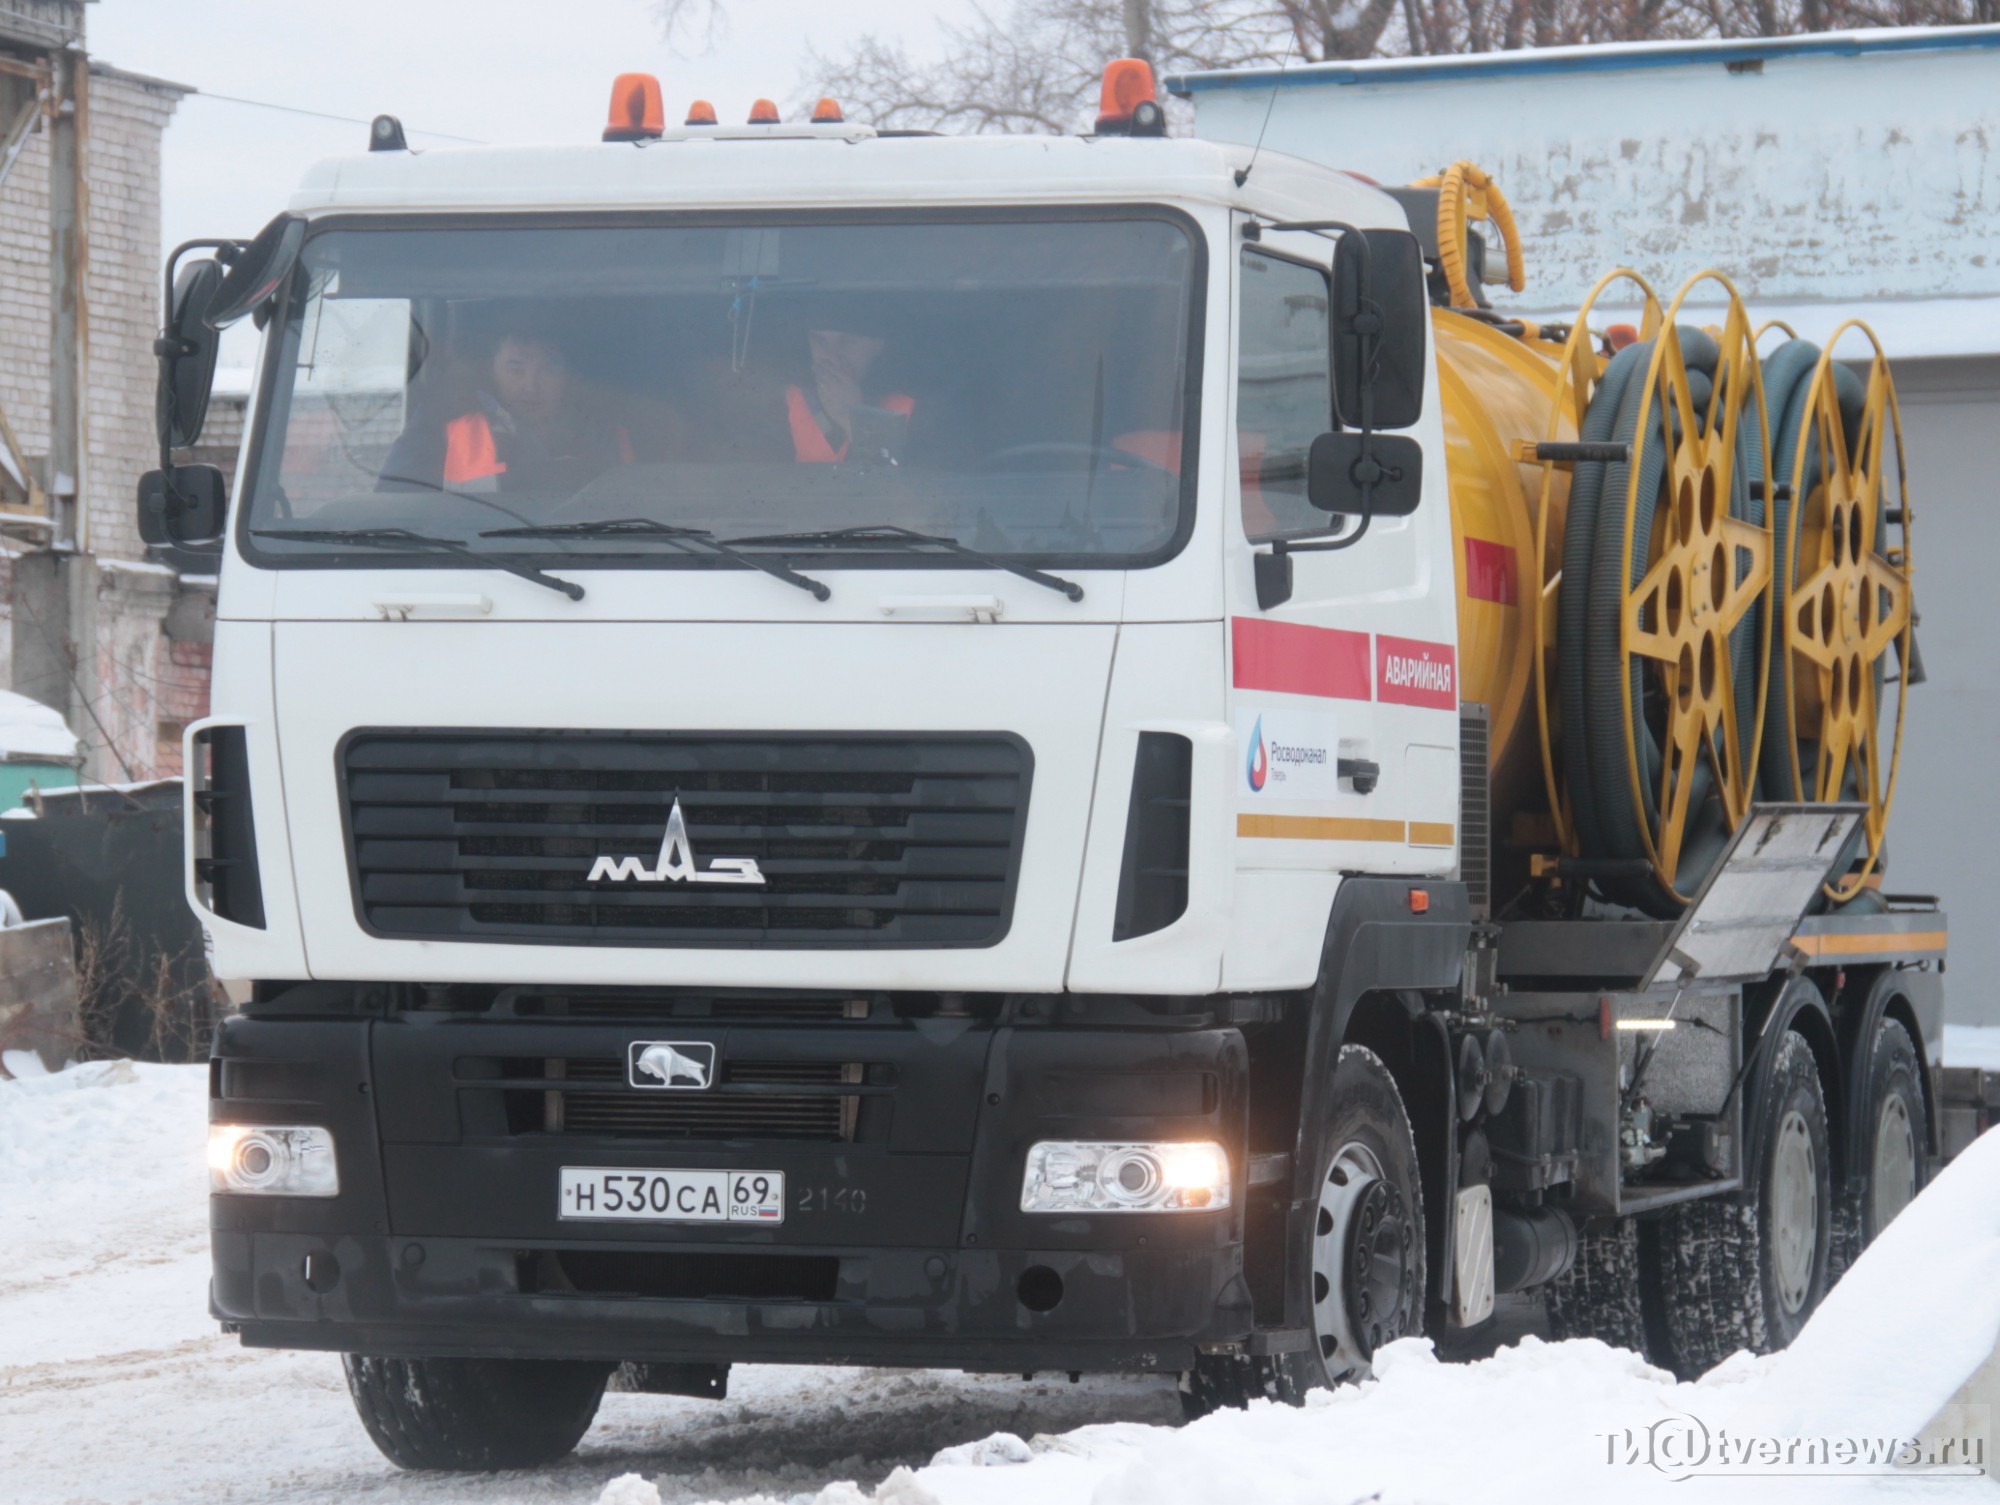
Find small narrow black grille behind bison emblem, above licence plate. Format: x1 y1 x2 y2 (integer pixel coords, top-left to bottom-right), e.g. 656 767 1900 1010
504 1059 866 1143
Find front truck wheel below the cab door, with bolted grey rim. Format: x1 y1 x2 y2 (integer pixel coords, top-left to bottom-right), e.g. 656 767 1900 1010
1180 1045 1424 1417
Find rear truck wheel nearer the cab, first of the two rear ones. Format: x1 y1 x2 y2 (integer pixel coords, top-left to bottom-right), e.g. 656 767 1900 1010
1646 1033 1834 1379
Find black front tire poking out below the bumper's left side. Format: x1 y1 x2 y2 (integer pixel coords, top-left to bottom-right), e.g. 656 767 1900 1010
342 1353 610 1471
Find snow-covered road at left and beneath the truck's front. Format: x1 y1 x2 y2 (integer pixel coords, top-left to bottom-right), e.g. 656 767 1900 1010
0 1063 1180 1505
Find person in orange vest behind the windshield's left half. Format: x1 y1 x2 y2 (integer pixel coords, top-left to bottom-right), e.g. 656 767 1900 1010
380 326 634 490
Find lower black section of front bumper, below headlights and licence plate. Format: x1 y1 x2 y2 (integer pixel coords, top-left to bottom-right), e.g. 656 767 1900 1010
212 1231 1250 1373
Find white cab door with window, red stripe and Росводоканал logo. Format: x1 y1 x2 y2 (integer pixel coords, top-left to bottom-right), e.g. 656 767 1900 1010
1230 232 1458 900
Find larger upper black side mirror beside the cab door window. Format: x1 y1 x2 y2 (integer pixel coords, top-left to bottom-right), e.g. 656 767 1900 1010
1330 230 1430 432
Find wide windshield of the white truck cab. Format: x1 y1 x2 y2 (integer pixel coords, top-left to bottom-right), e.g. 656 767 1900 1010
244 212 1198 568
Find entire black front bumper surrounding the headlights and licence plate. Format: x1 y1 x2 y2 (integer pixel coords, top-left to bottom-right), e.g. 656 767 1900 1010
210 999 1254 1371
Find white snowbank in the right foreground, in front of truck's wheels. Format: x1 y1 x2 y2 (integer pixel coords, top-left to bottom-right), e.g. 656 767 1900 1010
780 1135 2000 1505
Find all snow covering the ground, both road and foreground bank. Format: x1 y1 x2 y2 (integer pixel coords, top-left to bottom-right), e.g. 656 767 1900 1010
0 1037 2000 1505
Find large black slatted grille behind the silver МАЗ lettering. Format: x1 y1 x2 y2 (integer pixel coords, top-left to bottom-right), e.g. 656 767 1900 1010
340 730 1032 947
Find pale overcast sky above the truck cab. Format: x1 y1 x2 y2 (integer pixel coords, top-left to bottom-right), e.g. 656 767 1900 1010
88 0 964 254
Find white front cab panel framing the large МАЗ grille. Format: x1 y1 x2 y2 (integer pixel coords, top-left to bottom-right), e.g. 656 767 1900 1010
274 616 1120 991
